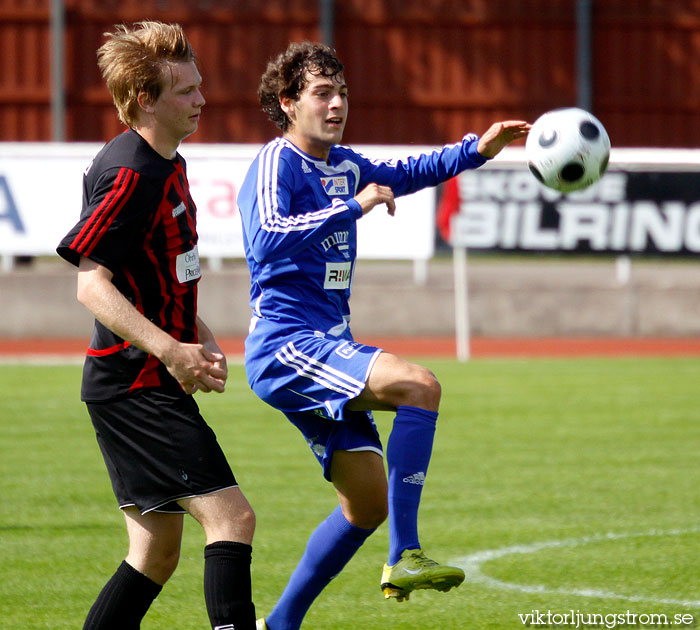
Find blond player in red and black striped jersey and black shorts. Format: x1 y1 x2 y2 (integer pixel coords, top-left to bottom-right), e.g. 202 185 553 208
58 22 255 630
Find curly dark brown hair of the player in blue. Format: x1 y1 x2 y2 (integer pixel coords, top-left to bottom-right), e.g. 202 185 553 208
258 42 343 131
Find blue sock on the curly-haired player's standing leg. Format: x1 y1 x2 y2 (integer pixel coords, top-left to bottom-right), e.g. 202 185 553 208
265 506 374 630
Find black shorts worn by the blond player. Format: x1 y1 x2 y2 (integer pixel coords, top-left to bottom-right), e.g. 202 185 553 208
87 389 237 514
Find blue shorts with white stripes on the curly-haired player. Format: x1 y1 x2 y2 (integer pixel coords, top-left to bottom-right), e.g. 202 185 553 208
246 320 382 481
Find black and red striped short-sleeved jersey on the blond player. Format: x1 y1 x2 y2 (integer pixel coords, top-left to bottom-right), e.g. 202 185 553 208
57 130 200 401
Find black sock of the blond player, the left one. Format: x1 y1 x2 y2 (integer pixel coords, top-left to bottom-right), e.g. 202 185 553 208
83 561 163 630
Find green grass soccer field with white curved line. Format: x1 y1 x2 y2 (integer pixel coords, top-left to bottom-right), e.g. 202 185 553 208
0 358 700 630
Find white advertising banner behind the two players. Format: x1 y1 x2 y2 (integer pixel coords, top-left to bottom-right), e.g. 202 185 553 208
0 143 435 272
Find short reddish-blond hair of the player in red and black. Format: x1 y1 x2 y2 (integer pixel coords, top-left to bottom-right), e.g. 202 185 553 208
97 21 196 127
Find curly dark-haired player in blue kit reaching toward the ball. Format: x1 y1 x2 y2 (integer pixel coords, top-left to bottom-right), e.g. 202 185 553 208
238 42 530 630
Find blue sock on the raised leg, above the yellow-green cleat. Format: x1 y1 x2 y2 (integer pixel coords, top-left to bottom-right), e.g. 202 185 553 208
386 406 438 565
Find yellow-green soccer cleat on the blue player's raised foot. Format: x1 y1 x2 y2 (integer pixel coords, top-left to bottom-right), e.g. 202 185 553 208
381 549 464 602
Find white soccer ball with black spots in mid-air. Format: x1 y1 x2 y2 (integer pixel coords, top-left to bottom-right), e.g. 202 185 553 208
525 107 610 193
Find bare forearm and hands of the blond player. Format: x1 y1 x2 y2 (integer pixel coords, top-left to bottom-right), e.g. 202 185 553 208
78 257 226 394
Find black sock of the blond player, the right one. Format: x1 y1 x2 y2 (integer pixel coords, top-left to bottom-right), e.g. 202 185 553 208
204 541 255 630
